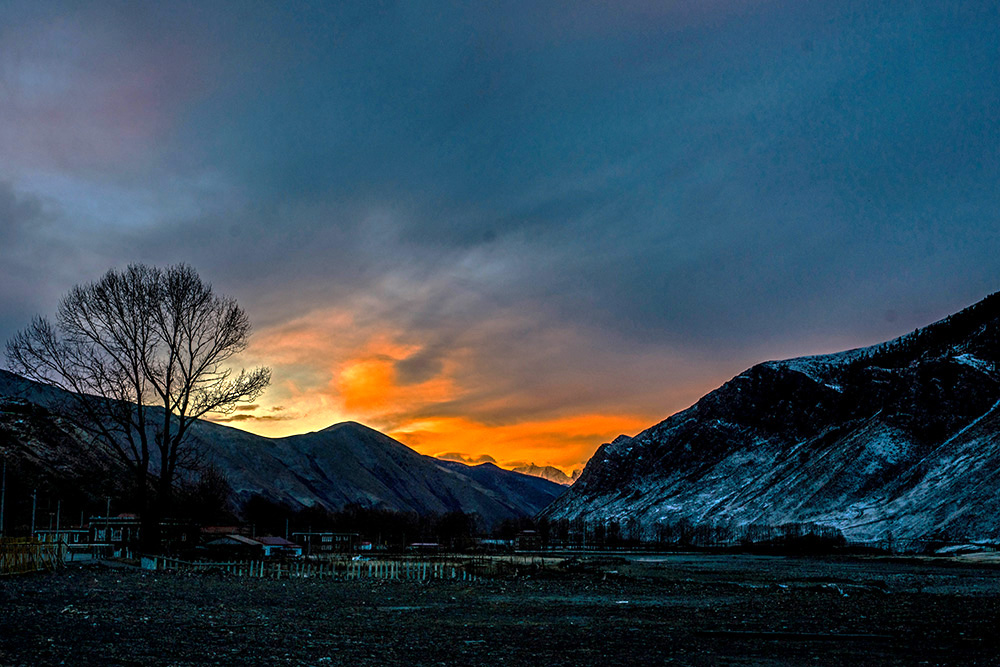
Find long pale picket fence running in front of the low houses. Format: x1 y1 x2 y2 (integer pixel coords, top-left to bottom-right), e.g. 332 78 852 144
142 556 481 581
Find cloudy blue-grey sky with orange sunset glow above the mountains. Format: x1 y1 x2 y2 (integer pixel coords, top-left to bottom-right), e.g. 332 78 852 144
0 0 1000 478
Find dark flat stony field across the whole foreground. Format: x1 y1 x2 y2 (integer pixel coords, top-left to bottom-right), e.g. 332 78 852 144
0 556 1000 666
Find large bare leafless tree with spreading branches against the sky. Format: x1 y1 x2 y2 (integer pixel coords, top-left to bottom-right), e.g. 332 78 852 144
7 264 271 546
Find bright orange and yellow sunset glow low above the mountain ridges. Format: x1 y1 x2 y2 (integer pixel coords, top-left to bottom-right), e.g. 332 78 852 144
211 310 728 473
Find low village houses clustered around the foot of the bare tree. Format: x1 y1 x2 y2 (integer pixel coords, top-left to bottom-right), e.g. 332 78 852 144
34 514 372 560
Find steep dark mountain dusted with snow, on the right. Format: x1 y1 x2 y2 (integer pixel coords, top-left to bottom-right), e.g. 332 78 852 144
542 293 1000 544
